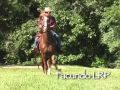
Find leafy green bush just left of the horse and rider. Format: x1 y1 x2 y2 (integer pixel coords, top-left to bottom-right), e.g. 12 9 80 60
5 20 38 63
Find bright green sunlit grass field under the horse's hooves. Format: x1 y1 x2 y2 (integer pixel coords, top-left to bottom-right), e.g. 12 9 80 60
0 66 120 90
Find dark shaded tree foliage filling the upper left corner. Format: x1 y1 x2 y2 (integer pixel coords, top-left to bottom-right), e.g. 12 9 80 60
0 0 39 32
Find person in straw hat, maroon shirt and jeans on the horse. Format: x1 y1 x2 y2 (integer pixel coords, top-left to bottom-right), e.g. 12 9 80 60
34 7 61 52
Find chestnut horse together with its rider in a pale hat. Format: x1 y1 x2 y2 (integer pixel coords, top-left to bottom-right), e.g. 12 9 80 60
35 7 60 75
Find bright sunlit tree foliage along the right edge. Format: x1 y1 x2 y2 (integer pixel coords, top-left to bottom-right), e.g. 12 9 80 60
100 0 120 67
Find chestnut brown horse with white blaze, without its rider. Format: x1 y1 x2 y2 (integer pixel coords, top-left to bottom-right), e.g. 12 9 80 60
39 17 58 75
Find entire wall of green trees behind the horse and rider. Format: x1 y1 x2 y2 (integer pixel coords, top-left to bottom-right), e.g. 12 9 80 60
0 0 120 67
